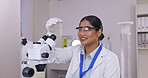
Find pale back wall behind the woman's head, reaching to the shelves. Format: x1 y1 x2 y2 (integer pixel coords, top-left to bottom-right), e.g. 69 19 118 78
50 0 137 78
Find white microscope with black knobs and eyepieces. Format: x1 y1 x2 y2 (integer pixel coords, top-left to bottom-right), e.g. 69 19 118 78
21 34 56 78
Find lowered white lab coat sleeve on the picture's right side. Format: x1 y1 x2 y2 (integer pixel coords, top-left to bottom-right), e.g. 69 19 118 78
104 53 120 78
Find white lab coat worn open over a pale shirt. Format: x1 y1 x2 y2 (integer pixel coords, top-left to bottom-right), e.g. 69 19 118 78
49 45 120 78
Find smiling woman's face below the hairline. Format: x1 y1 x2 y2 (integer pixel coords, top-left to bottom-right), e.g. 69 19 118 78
78 20 102 46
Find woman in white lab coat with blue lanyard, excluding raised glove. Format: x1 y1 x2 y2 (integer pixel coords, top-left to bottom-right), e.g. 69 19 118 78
49 15 120 78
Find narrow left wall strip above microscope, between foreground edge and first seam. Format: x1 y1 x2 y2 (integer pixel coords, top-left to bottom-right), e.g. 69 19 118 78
21 0 34 41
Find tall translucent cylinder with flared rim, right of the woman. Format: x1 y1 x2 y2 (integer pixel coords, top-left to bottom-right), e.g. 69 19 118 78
118 21 133 78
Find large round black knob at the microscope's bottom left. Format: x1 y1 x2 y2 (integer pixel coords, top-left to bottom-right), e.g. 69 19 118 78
22 67 34 77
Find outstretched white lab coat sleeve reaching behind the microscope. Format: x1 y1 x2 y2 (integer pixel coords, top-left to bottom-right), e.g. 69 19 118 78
48 46 78 63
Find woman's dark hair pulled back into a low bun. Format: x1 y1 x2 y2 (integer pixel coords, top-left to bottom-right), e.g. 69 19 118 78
79 15 104 41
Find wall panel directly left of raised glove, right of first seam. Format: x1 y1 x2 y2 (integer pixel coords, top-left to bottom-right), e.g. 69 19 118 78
33 0 49 41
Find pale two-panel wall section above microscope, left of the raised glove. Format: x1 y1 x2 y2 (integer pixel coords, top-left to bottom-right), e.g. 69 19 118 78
21 0 49 41
